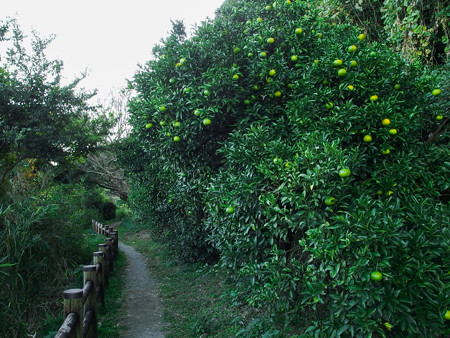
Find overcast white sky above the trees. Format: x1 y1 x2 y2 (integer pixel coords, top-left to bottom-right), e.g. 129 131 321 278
0 0 224 103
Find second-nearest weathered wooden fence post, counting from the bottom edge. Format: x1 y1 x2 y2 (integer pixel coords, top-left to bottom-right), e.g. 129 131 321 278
83 265 97 338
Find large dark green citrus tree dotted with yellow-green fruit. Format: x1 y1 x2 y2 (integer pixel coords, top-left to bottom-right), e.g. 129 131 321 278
124 1 450 337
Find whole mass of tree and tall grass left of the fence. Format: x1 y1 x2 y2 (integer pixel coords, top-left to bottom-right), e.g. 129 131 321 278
0 20 114 337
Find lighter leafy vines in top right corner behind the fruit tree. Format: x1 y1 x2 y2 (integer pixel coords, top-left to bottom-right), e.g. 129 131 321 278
319 0 450 64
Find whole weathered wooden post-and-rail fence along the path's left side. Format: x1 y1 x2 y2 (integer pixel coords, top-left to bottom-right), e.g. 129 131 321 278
55 220 119 338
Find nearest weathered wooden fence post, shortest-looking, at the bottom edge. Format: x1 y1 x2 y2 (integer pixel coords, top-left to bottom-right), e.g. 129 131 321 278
55 289 83 338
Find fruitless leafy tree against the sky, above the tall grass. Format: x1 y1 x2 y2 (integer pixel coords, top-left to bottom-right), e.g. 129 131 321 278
0 21 109 183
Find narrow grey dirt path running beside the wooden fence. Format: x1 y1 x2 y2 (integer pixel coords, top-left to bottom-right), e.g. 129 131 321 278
119 241 165 338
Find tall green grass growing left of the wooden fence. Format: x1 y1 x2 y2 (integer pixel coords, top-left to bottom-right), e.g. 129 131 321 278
0 173 107 337
